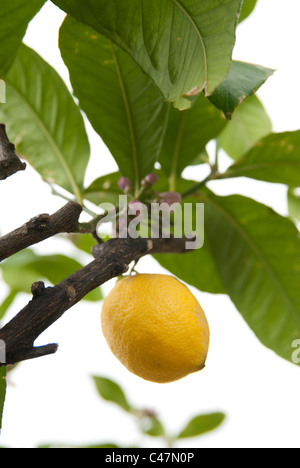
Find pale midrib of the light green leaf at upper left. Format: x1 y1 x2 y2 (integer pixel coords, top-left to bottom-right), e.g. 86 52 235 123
6 77 82 204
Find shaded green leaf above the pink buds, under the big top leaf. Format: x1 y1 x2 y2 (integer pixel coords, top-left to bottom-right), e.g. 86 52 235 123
159 95 226 183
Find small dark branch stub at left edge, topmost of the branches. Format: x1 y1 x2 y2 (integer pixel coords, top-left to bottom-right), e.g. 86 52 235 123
0 124 26 180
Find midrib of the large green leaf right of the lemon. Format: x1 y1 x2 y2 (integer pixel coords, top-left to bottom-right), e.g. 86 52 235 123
202 194 300 325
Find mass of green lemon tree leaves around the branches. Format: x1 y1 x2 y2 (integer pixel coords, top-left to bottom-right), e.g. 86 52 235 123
0 0 300 437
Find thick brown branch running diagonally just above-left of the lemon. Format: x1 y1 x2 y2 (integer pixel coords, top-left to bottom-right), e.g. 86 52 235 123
0 239 193 364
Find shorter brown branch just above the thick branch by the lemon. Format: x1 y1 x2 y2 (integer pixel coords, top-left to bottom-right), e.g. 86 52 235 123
0 202 82 262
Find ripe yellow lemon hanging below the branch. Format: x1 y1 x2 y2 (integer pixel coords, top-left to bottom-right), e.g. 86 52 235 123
101 274 209 383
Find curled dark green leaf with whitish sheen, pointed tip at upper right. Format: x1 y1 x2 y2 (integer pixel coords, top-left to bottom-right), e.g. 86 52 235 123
209 61 274 120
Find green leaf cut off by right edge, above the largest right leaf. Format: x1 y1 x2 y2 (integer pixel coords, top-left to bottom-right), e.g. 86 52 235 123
228 131 300 187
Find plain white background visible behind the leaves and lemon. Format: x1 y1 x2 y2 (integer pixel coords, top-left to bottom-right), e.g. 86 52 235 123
0 0 300 448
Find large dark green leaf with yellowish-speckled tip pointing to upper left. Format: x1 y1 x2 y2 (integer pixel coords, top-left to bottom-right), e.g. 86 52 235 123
60 17 168 190
